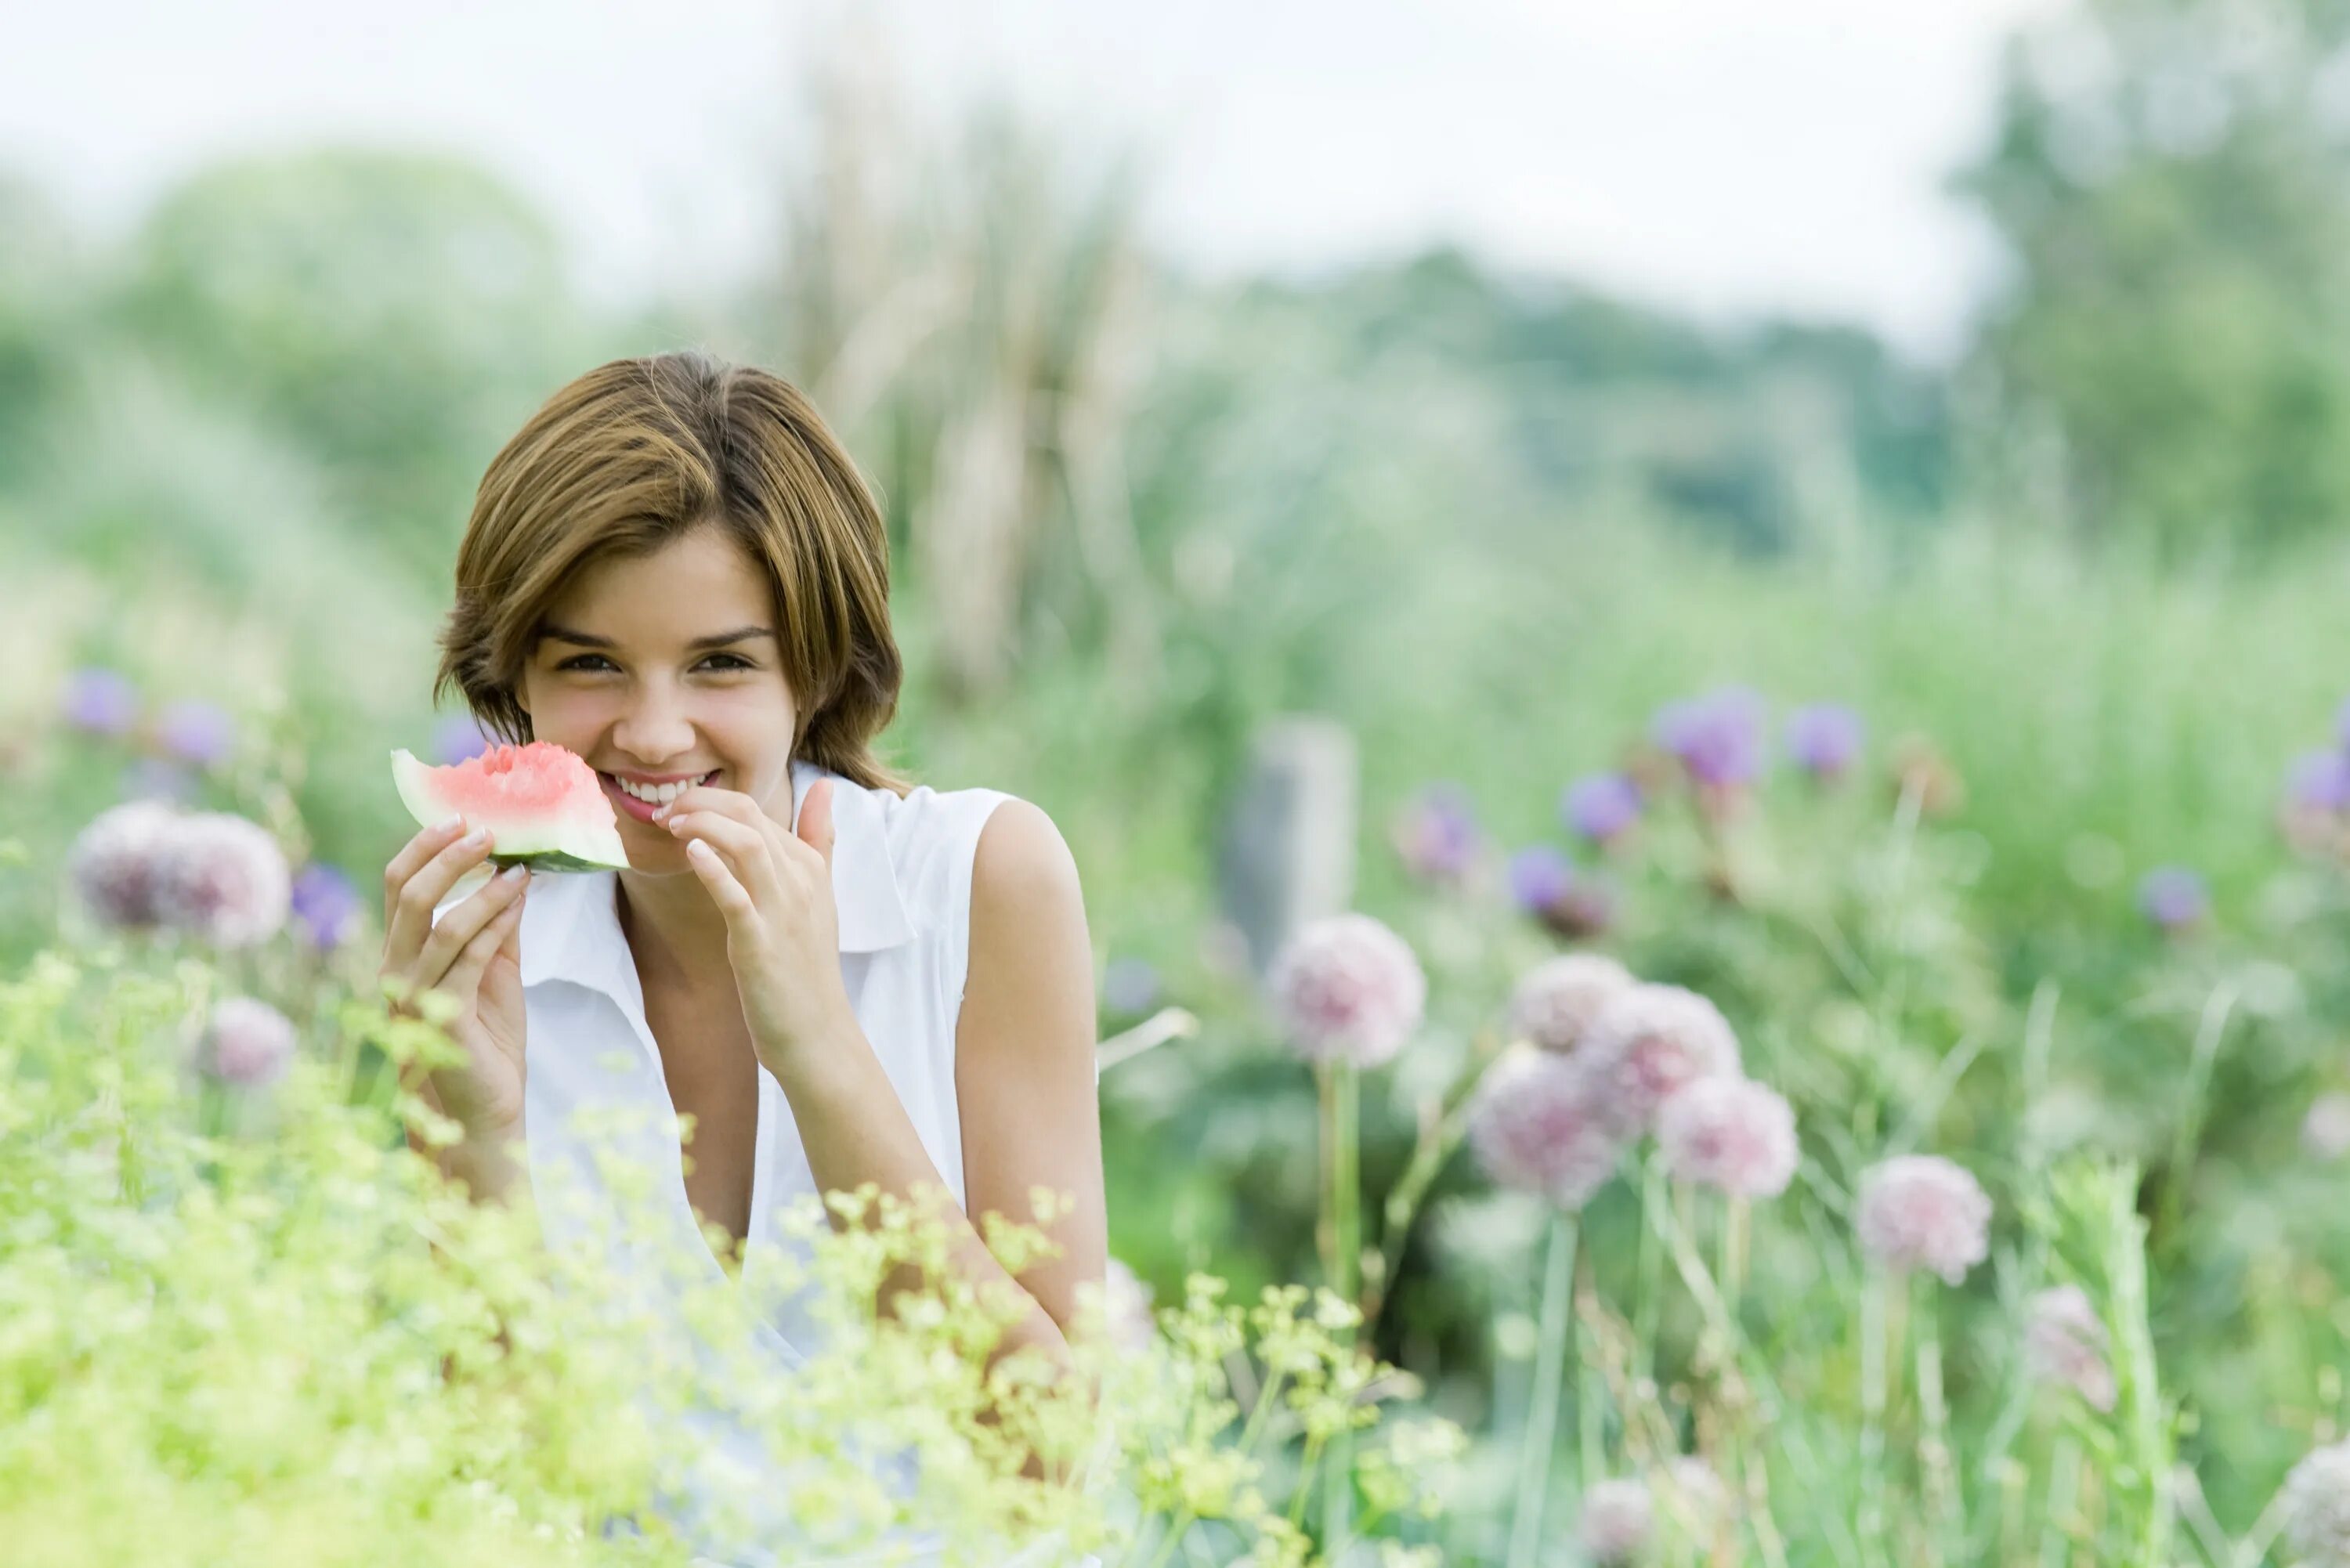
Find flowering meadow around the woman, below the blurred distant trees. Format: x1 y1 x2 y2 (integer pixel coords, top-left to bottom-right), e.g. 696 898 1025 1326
13 510 2350 1568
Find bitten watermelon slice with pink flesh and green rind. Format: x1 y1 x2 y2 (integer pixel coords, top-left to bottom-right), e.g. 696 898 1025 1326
392 740 627 877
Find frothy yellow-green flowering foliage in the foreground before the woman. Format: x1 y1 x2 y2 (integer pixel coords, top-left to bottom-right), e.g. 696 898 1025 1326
0 948 1459 1568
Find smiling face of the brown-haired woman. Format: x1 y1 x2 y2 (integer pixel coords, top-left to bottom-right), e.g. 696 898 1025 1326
517 529 797 861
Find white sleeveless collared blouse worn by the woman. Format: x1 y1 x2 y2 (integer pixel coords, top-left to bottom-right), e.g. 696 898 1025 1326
435 761 1058 1568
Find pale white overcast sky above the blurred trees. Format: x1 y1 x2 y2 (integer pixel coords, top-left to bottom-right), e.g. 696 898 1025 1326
0 0 2052 355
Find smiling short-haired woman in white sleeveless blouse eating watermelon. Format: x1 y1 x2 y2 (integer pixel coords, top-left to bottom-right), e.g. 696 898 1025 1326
383 350 1107 1560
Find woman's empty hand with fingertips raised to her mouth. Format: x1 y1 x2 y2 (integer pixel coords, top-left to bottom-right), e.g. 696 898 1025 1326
663 778 853 1070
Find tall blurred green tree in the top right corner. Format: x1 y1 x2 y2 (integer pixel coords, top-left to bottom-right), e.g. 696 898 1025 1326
1958 0 2350 555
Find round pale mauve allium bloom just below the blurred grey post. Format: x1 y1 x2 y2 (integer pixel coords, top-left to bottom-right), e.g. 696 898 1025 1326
1267 912 1429 1068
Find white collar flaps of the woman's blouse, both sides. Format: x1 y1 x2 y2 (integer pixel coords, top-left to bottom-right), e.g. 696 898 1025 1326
522 757 914 990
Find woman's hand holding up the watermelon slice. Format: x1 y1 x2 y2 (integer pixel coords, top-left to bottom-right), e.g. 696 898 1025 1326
381 823 529 1138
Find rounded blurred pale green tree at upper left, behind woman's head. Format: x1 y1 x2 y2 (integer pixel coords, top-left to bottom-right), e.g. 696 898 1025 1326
113 148 585 580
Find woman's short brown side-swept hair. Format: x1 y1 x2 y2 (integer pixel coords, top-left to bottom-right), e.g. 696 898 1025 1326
432 348 909 795
